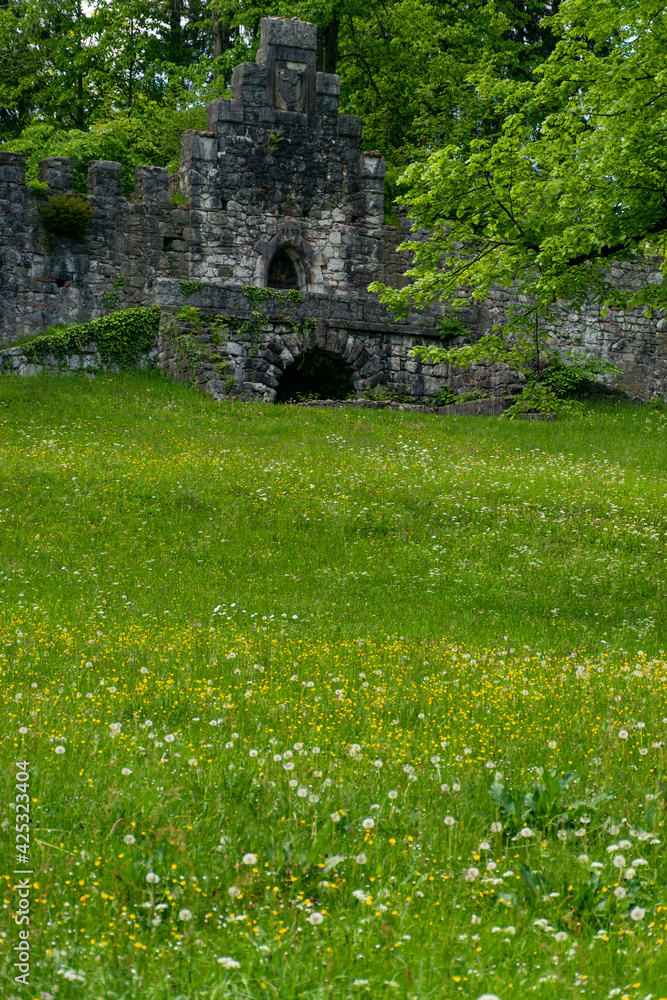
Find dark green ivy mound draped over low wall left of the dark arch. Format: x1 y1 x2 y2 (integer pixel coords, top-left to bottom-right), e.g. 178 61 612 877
21 306 160 367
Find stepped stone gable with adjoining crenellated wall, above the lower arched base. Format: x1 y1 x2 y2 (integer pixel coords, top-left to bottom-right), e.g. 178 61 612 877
0 18 418 344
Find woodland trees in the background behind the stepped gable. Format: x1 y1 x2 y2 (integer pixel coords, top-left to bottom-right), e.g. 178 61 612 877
0 0 564 187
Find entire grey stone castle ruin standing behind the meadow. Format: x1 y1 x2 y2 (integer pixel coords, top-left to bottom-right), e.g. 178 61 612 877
0 18 667 403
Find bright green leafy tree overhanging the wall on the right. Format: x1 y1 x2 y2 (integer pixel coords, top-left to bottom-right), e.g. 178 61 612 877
376 0 667 324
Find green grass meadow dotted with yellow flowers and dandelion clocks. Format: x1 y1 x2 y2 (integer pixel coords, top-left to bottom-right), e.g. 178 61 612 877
0 374 667 1000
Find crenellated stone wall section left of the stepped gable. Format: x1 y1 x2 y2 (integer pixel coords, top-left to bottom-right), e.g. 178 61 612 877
0 151 189 344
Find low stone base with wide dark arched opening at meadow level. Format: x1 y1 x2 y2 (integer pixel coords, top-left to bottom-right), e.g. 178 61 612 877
158 289 520 405
